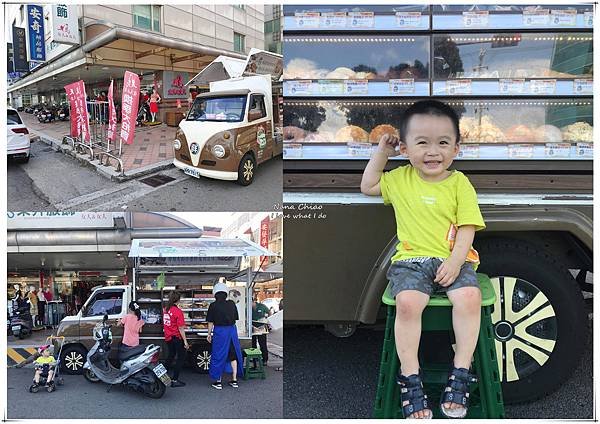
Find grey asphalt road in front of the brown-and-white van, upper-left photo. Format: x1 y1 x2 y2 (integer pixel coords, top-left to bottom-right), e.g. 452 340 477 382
7 141 282 212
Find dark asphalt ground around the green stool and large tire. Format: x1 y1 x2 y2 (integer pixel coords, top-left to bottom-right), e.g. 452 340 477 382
283 322 594 419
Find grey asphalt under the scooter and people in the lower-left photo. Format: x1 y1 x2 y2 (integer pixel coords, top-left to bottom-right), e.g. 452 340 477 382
7 367 283 419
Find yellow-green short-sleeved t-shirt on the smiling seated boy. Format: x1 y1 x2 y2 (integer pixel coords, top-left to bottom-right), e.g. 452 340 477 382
379 165 485 264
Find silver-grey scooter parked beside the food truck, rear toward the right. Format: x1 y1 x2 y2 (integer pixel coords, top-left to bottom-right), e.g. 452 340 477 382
83 314 171 399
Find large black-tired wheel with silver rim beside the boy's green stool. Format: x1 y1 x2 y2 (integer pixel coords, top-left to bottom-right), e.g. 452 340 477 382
475 239 588 404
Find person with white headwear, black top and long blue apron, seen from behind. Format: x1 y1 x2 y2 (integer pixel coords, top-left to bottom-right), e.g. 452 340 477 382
206 283 244 390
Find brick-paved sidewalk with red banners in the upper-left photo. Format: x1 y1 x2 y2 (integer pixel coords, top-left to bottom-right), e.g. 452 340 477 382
20 112 177 181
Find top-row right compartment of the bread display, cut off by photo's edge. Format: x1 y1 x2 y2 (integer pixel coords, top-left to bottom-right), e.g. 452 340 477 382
432 4 594 30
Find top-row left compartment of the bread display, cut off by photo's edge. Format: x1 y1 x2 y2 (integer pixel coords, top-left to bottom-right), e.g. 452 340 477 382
283 5 430 32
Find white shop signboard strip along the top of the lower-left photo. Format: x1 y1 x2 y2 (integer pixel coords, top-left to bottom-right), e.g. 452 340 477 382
7 212 125 231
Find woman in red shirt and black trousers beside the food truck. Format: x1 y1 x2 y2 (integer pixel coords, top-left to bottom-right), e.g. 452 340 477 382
163 291 190 387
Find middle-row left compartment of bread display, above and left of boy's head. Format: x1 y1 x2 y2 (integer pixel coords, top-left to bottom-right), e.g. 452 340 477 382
283 35 430 97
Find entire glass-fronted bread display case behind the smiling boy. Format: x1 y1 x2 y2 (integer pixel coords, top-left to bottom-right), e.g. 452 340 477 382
283 5 593 164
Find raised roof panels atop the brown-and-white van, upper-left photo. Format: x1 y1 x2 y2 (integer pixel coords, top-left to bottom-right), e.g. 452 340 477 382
186 48 283 85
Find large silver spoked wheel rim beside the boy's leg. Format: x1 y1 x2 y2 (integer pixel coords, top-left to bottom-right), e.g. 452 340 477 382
491 276 557 383
